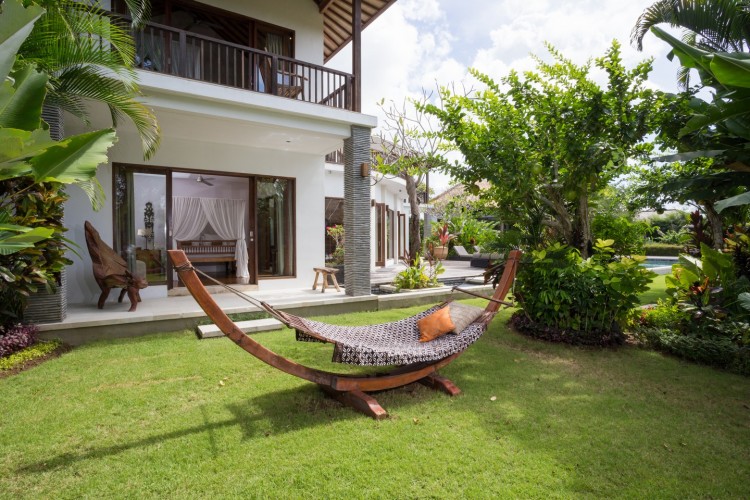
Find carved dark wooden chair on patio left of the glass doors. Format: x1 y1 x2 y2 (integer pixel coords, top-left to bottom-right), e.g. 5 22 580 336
84 221 148 312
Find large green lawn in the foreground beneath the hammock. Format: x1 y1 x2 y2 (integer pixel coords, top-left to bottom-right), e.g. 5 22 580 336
0 301 750 499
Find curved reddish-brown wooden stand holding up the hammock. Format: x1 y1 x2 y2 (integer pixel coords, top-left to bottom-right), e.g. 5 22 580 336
168 250 521 419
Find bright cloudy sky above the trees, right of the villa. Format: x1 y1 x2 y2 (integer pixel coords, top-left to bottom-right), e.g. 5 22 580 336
329 0 678 193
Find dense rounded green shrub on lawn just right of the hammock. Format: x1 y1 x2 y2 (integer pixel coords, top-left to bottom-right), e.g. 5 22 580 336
513 240 655 344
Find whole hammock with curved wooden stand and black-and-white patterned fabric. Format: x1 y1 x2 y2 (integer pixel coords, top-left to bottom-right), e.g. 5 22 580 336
168 250 521 418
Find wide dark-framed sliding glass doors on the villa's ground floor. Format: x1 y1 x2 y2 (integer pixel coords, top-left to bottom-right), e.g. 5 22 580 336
113 164 296 288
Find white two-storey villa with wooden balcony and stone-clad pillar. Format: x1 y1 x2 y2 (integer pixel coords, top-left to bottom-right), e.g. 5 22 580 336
58 0 396 316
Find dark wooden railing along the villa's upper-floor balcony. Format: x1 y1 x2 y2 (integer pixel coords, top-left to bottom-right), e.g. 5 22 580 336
125 18 353 110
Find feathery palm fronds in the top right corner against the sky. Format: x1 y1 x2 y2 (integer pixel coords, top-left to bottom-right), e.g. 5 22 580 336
630 0 750 88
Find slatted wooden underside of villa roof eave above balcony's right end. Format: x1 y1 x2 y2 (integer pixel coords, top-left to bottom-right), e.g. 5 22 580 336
313 0 396 62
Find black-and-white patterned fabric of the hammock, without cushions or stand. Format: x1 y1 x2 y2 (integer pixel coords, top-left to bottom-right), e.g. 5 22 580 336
286 306 489 366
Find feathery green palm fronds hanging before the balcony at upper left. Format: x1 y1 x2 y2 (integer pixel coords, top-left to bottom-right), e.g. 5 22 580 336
19 0 160 158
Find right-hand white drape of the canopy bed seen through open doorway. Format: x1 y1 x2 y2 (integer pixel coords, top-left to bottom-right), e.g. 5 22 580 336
198 198 250 278
